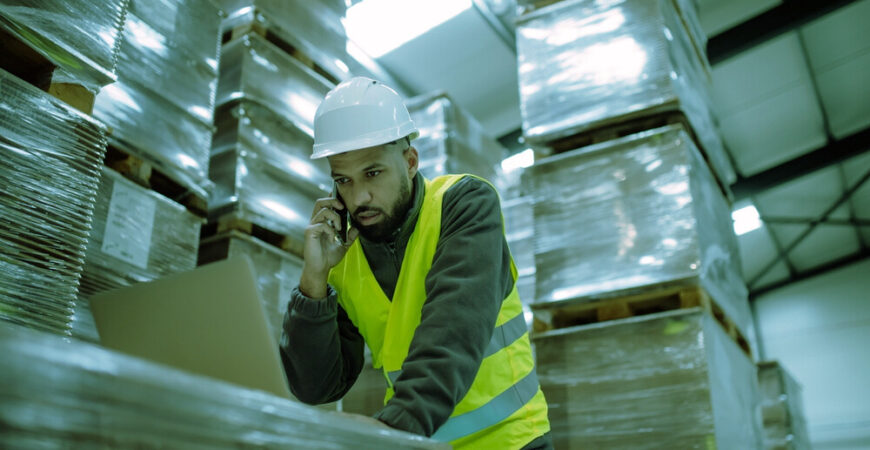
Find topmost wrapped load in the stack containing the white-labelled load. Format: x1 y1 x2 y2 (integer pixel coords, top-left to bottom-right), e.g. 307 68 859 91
118 0 222 124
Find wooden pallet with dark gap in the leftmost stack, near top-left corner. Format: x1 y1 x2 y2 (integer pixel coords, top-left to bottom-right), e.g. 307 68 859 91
0 24 96 114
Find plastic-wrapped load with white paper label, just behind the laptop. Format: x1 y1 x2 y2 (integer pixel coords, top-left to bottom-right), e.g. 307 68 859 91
73 167 202 342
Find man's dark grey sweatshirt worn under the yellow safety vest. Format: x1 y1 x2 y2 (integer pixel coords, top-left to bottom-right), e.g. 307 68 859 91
281 174 513 436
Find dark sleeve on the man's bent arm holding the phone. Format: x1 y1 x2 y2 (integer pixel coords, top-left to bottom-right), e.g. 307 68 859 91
280 286 365 405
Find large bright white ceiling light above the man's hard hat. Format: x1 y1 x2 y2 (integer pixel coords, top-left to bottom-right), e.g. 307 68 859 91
342 0 471 58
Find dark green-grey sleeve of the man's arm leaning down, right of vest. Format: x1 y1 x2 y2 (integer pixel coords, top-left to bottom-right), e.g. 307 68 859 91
375 177 513 436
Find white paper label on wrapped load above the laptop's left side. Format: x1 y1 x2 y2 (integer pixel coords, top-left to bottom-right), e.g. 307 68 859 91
102 181 157 269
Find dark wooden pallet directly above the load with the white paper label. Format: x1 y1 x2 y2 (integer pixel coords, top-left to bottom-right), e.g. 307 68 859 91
103 144 208 218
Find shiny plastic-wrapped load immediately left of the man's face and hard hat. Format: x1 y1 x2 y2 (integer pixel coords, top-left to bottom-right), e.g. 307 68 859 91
209 101 332 242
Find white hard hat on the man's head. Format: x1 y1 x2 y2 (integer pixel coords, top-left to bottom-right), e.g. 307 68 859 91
311 77 420 159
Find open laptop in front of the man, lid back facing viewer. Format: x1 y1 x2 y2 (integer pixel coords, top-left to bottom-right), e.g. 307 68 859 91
90 255 293 399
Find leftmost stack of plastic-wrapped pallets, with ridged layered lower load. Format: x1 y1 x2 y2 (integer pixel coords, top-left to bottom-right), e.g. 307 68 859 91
0 0 127 335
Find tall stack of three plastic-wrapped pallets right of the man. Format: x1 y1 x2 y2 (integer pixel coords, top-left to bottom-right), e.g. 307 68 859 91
517 0 761 448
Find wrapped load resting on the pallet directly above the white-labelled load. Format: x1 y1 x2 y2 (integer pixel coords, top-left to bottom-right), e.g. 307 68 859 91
94 77 212 198
